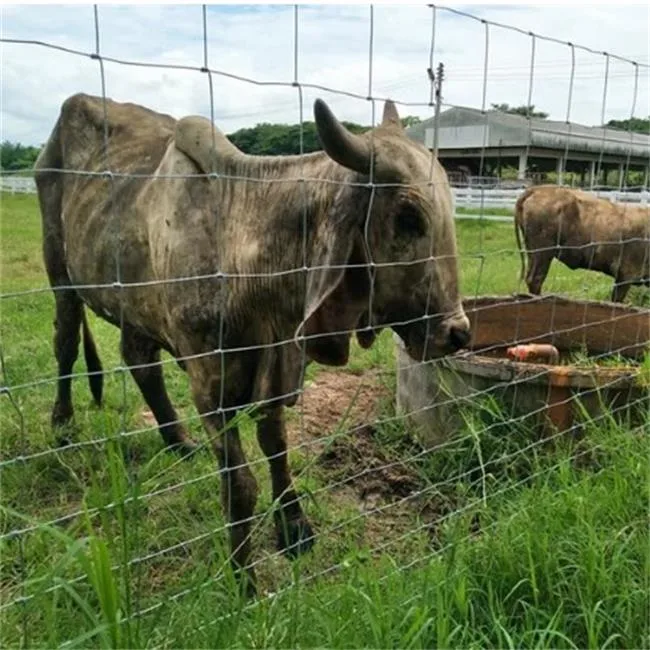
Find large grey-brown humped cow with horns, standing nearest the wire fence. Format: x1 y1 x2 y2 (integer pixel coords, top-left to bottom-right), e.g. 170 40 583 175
35 94 470 594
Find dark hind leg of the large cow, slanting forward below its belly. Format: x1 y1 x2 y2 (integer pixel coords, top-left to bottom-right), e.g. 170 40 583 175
122 326 196 456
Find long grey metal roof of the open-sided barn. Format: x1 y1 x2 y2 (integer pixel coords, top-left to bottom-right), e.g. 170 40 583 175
407 107 650 158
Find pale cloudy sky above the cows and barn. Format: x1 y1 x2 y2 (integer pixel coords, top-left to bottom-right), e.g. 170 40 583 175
0 3 650 145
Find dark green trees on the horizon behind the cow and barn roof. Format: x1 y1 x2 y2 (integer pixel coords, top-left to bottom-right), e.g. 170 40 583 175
0 104 650 171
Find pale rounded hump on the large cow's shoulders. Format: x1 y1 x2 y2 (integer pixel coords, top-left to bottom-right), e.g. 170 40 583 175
174 115 245 174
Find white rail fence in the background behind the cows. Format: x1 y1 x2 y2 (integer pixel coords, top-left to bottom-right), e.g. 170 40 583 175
0 176 650 210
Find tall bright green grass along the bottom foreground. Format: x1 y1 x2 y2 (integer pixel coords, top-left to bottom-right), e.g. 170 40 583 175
3 408 650 648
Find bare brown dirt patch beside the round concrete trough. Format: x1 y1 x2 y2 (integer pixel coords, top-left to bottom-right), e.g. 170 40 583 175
280 371 451 548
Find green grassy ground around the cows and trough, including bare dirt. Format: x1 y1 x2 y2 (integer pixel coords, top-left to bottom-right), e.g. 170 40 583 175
0 195 650 648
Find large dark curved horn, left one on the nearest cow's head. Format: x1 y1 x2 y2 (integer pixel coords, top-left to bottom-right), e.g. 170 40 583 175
314 99 370 174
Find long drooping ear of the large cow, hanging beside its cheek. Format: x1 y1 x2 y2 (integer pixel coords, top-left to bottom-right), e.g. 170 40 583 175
297 192 370 366
